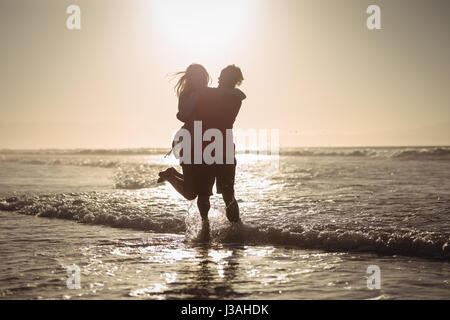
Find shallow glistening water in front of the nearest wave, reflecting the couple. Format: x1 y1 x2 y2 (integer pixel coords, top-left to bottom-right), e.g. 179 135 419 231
0 212 450 299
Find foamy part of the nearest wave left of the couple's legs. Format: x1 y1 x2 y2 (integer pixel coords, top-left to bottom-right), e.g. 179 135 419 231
0 192 185 233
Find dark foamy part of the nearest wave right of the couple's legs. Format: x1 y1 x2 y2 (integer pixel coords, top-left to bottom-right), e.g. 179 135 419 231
216 225 450 260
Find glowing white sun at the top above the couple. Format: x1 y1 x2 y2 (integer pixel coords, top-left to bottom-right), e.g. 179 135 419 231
152 0 255 51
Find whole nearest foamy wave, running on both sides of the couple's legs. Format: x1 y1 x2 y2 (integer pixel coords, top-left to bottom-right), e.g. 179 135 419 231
0 192 450 260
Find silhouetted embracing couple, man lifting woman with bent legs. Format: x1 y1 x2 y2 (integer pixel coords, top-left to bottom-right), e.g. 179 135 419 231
158 64 246 222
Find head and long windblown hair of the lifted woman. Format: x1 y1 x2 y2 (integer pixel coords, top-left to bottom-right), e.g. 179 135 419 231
175 63 210 97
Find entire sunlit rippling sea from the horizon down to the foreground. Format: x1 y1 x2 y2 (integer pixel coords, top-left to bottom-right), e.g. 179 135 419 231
0 147 450 299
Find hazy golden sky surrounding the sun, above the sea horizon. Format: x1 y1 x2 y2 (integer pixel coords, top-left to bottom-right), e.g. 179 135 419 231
0 0 450 148
